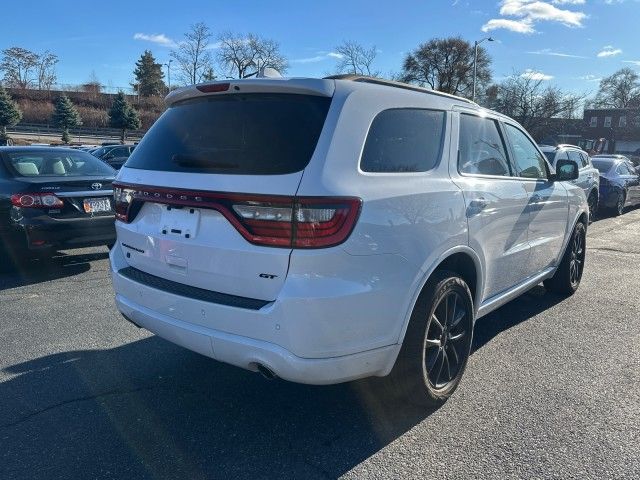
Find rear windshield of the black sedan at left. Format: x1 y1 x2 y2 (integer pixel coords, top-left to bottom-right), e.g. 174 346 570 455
5 150 115 177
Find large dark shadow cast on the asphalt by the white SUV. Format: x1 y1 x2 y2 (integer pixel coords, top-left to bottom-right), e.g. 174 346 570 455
0 289 561 479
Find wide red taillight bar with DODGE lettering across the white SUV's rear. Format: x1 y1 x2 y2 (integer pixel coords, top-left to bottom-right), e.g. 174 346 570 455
114 183 361 248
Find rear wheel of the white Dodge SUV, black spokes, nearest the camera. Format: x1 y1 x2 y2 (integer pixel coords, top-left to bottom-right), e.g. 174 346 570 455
384 271 474 408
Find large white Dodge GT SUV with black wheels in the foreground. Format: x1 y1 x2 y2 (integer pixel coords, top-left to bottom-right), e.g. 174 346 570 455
110 76 588 405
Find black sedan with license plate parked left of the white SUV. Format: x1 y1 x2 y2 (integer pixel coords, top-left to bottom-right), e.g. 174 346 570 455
0 147 116 263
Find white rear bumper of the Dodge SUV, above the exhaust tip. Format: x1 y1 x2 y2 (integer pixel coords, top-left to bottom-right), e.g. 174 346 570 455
110 245 406 385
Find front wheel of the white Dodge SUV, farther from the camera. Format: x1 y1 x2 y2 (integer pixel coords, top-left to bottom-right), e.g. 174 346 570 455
543 221 587 295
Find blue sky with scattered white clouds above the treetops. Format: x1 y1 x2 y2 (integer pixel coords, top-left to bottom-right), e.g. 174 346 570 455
0 0 640 93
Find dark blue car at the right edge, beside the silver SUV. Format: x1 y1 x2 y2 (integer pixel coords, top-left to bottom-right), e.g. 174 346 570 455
591 155 640 215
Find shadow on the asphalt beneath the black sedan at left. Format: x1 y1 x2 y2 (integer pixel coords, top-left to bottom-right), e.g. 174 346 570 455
0 251 109 291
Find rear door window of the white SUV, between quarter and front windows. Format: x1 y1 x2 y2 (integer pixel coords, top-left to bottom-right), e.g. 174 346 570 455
458 114 511 177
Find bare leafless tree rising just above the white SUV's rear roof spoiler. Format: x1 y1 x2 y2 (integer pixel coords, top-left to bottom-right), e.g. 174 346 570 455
218 32 289 78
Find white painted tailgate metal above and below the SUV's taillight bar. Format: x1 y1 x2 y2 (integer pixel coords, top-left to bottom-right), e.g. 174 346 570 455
116 171 302 301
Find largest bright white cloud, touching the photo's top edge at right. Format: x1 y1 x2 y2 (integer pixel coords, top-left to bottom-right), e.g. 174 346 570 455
482 0 587 33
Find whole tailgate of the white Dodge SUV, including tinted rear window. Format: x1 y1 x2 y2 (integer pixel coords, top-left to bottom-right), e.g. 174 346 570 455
115 87 331 301
